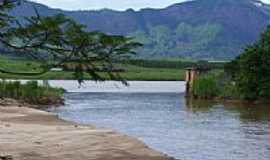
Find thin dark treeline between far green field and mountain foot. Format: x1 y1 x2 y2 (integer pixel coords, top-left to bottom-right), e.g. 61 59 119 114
119 59 226 69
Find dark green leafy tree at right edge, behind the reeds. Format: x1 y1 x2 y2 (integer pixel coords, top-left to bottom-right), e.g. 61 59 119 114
227 27 270 100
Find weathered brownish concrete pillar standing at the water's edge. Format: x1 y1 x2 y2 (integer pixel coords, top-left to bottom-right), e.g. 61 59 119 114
186 66 210 96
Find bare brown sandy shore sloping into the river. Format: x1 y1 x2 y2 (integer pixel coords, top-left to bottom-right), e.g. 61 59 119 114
0 106 169 160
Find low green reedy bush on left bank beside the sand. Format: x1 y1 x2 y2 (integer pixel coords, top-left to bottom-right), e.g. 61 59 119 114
0 80 64 105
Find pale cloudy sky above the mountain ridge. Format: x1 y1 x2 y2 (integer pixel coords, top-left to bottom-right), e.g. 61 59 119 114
32 0 270 10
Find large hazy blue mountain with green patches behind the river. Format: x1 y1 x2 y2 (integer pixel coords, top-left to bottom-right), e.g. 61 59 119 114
8 0 270 59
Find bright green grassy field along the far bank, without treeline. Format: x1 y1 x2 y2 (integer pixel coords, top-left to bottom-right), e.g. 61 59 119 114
0 57 185 81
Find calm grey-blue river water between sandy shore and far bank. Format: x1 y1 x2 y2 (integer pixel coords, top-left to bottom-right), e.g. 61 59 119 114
47 81 270 160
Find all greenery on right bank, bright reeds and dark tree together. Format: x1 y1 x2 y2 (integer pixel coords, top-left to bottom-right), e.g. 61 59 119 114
192 26 270 101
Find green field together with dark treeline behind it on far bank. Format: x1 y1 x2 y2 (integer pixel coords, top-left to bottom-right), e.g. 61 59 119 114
0 56 228 81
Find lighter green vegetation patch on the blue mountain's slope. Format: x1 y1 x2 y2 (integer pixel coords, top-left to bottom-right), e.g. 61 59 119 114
131 23 228 59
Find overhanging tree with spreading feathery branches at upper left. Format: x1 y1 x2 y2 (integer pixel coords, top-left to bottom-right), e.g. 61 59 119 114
0 0 141 82
